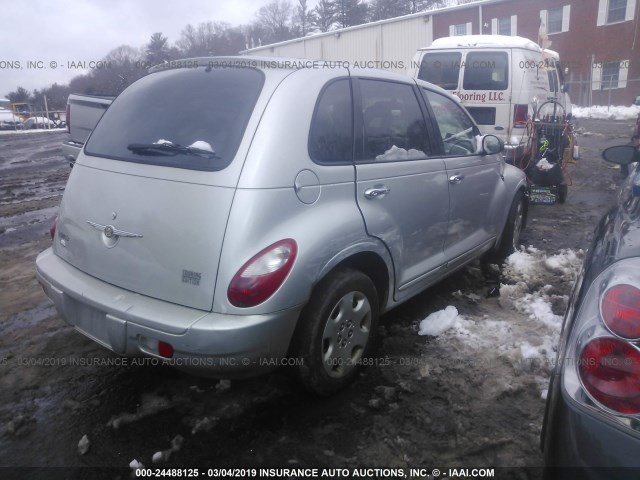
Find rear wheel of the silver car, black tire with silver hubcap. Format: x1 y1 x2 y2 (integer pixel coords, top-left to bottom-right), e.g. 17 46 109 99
292 268 379 396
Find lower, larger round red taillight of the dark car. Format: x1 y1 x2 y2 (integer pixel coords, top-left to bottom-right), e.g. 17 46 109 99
578 337 640 415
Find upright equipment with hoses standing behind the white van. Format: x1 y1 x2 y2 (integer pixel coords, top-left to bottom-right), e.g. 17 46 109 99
507 99 578 205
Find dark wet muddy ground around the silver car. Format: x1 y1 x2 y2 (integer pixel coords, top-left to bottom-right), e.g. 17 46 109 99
0 120 633 478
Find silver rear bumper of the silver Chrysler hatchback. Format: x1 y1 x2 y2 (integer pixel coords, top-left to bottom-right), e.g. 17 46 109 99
36 248 302 378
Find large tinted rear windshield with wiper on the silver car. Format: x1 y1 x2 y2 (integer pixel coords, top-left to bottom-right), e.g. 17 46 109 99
85 67 264 171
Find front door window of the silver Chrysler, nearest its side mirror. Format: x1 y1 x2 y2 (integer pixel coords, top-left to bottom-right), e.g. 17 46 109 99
422 89 478 156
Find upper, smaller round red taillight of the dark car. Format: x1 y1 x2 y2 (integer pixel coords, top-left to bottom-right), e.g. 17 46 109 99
601 284 640 340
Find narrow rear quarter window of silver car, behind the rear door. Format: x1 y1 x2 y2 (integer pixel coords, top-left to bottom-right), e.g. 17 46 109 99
309 78 353 164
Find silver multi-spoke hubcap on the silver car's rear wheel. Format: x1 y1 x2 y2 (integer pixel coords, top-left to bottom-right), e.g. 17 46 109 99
322 292 371 378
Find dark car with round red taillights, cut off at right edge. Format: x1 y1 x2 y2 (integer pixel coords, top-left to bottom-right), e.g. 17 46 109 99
541 146 640 480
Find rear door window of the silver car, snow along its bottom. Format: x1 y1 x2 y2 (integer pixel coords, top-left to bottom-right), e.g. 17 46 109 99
359 79 431 162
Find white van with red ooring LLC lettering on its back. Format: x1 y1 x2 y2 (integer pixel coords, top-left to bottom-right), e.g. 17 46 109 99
413 35 571 161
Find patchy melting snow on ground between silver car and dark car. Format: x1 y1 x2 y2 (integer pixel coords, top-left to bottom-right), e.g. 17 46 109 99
418 247 584 378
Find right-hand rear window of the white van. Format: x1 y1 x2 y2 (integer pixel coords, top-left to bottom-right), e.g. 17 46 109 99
462 52 509 90
